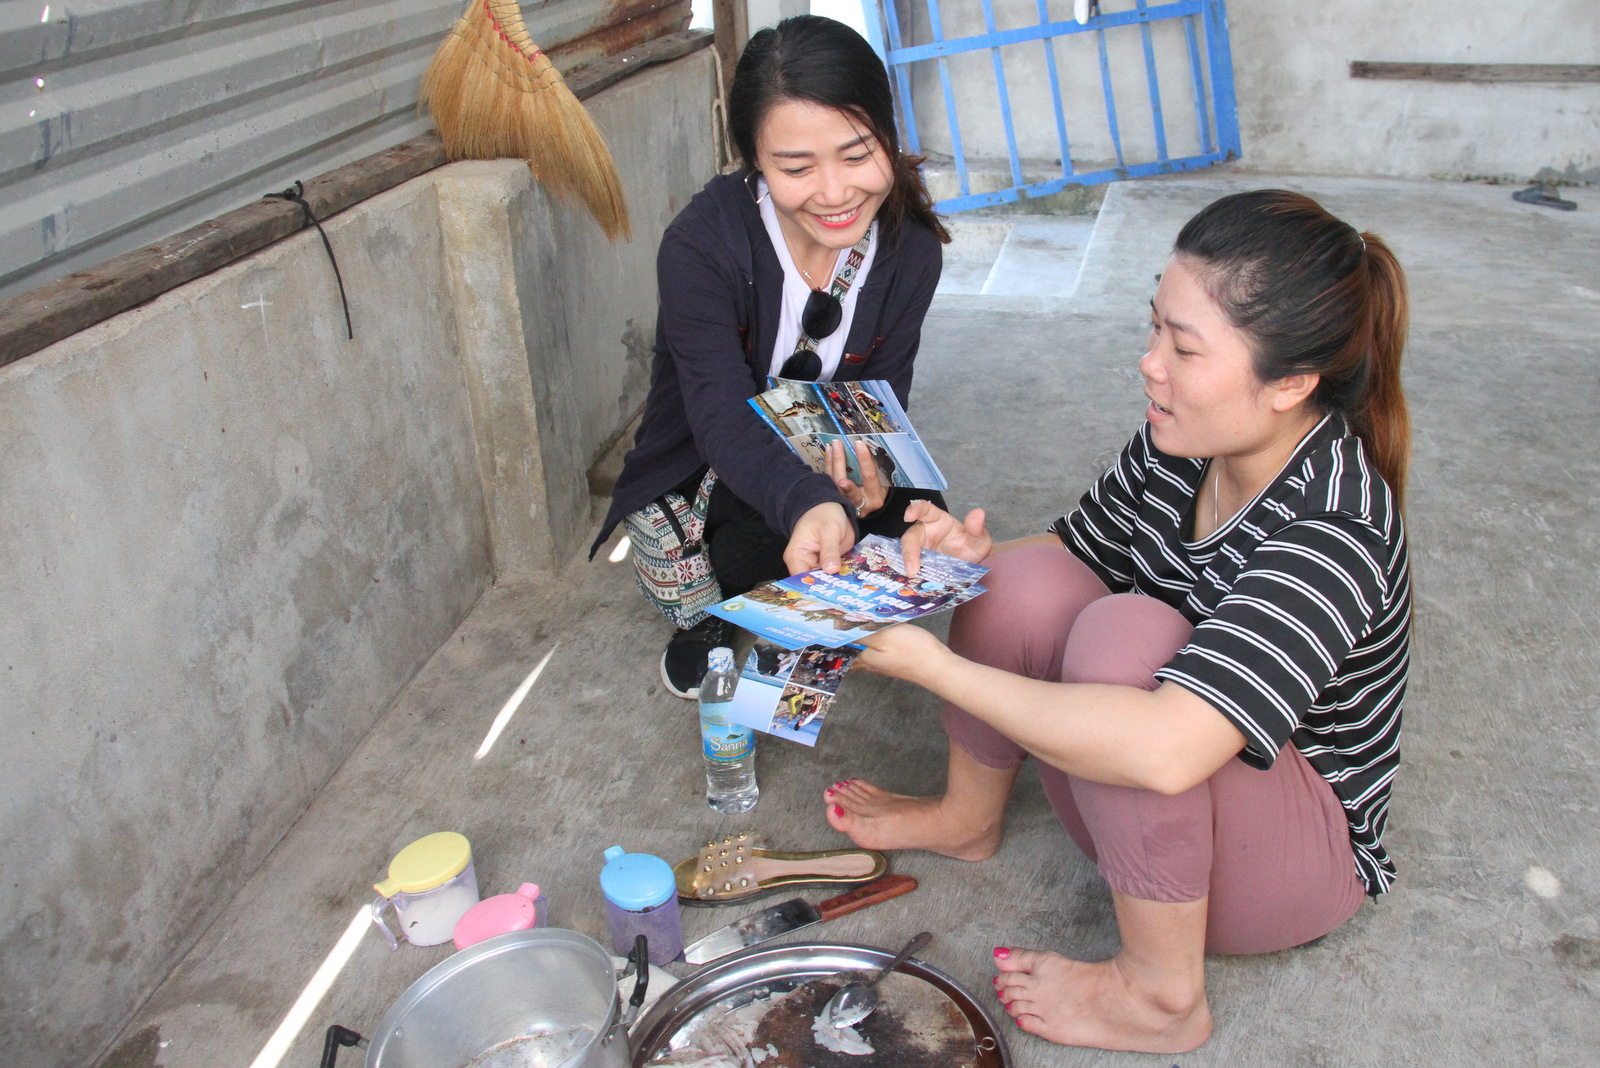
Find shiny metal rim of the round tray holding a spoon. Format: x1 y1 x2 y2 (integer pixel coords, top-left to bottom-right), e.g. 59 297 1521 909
630 942 1011 1068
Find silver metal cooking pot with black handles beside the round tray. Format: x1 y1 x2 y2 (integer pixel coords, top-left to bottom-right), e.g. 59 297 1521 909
322 927 650 1068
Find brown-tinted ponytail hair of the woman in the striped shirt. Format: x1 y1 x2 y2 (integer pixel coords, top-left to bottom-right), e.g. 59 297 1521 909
1173 189 1411 504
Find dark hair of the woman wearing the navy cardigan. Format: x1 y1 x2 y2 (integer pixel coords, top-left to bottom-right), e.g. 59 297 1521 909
728 14 950 243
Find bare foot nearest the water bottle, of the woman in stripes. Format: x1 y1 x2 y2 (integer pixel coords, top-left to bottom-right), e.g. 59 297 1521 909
822 779 1005 860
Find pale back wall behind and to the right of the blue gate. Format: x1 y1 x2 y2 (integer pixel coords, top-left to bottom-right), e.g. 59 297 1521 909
902 0 1600 181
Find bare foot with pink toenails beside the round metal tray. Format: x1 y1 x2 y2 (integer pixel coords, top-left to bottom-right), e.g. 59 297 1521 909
994 950 1211 1054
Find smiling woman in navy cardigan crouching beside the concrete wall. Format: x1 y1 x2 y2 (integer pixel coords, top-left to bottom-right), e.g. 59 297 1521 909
590 16 950 699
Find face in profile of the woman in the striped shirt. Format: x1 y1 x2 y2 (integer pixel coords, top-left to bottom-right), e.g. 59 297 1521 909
1139 256 1318 459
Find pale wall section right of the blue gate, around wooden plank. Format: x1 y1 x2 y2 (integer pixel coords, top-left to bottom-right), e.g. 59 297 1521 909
1229 0 1600 182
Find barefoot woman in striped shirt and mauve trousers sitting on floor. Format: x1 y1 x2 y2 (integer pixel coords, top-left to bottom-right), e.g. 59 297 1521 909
826 190 1411 1054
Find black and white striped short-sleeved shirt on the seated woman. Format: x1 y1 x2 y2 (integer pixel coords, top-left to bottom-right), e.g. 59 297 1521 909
1051 416 1411 894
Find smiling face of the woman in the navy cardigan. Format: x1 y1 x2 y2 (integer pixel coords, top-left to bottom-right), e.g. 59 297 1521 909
755 101 894 267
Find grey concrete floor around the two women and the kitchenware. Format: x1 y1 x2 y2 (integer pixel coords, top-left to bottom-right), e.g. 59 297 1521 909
103 173 1600 1068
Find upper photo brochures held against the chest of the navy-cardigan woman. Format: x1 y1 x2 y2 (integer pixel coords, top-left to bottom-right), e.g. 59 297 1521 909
750 379 949 489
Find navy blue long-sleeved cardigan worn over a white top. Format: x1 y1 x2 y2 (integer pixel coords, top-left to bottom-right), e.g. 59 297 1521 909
589 174 942 558
